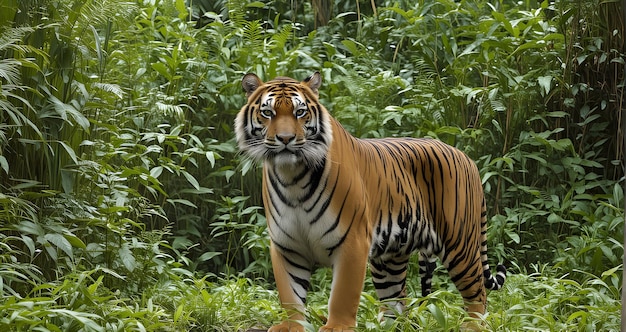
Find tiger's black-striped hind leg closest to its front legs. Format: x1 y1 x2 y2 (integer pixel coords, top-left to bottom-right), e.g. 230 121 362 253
370 257 409 316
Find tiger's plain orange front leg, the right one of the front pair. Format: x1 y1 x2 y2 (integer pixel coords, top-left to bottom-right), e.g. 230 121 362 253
319 233 369 332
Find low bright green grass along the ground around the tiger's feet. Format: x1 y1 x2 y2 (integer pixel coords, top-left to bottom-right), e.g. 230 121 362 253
0 268 621 331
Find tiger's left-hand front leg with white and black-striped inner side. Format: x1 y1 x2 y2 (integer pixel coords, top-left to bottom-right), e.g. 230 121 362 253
268 244 311 332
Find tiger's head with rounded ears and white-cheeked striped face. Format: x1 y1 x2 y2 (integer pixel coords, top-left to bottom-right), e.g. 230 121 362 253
235 72 332 167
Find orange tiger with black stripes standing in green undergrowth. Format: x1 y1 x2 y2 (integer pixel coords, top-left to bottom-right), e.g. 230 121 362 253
234 72 506 332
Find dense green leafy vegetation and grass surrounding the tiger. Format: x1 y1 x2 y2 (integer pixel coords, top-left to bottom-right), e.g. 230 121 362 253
0 0 626 331
